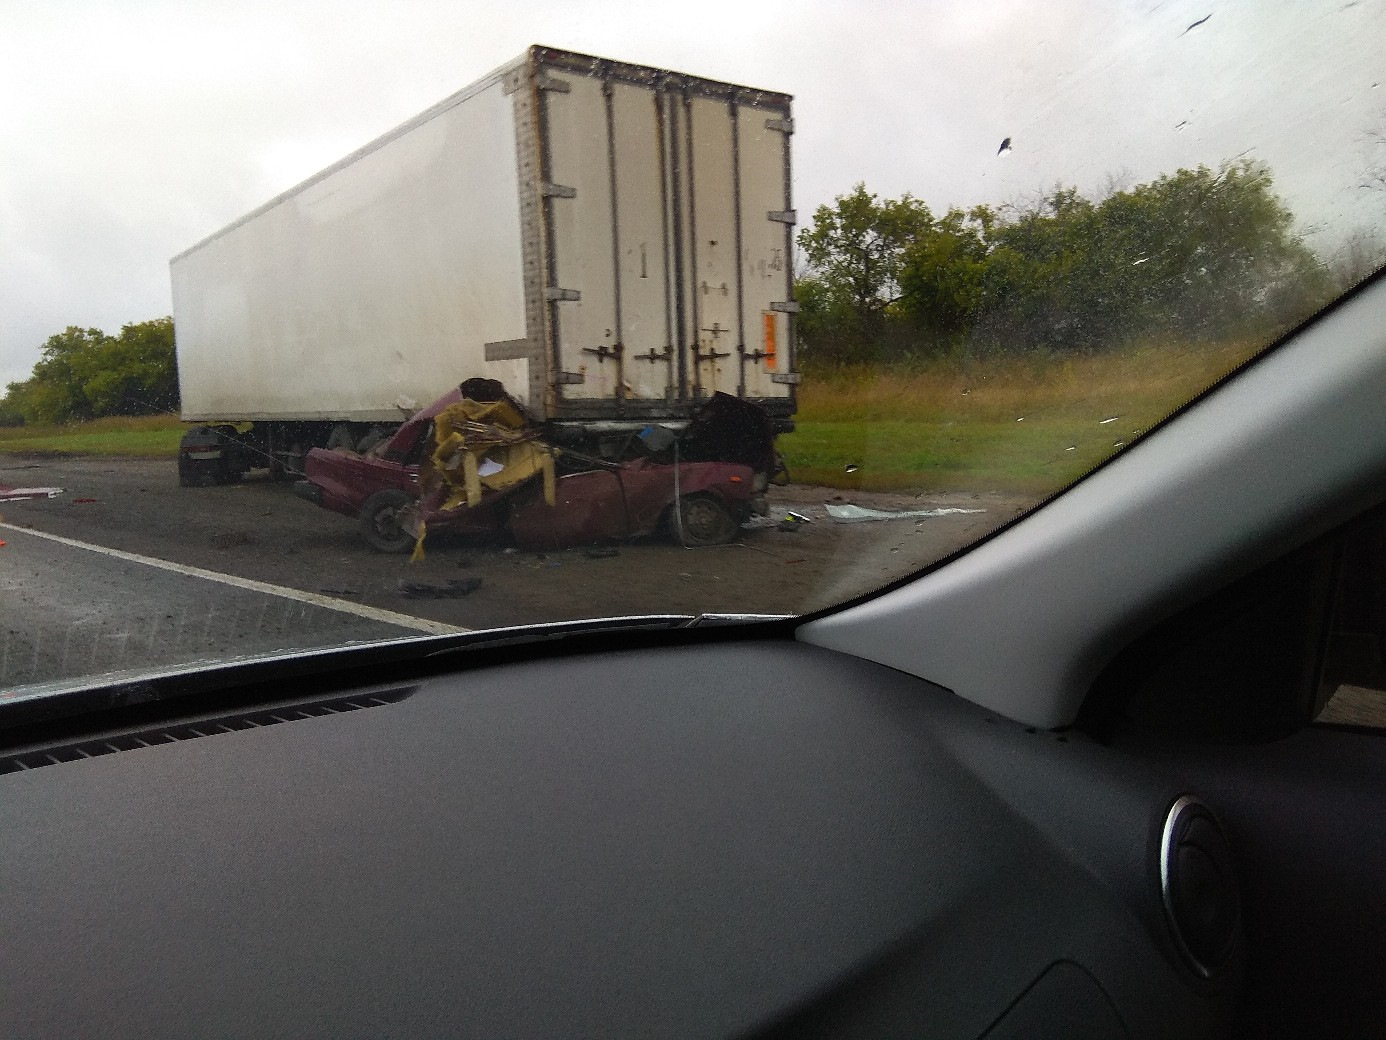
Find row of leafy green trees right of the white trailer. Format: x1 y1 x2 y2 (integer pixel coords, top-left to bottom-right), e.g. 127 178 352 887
797 161 1313 361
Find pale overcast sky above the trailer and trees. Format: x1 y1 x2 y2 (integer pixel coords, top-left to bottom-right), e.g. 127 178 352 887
0 0 1386 384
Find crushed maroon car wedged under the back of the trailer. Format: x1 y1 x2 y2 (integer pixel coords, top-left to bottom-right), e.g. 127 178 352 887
294 380 779 552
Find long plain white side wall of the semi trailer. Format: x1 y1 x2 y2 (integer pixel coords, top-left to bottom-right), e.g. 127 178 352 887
172 71 529 420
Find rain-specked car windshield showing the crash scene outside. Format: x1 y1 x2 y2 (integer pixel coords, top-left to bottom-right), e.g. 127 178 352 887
0 0 1386 697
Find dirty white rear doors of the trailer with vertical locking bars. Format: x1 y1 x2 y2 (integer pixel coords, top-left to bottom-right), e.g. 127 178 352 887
535 51 794 416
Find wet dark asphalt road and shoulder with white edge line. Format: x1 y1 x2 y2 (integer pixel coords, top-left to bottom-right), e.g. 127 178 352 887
0 455 1027 696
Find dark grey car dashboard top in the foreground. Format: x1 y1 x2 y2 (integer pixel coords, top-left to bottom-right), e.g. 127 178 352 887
0 632 1243 1037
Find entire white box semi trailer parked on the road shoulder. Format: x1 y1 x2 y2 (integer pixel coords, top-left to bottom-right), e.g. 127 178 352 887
170 39 798 483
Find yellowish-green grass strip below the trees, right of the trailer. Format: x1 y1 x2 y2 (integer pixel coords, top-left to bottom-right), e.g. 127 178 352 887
779 343 1257 494
